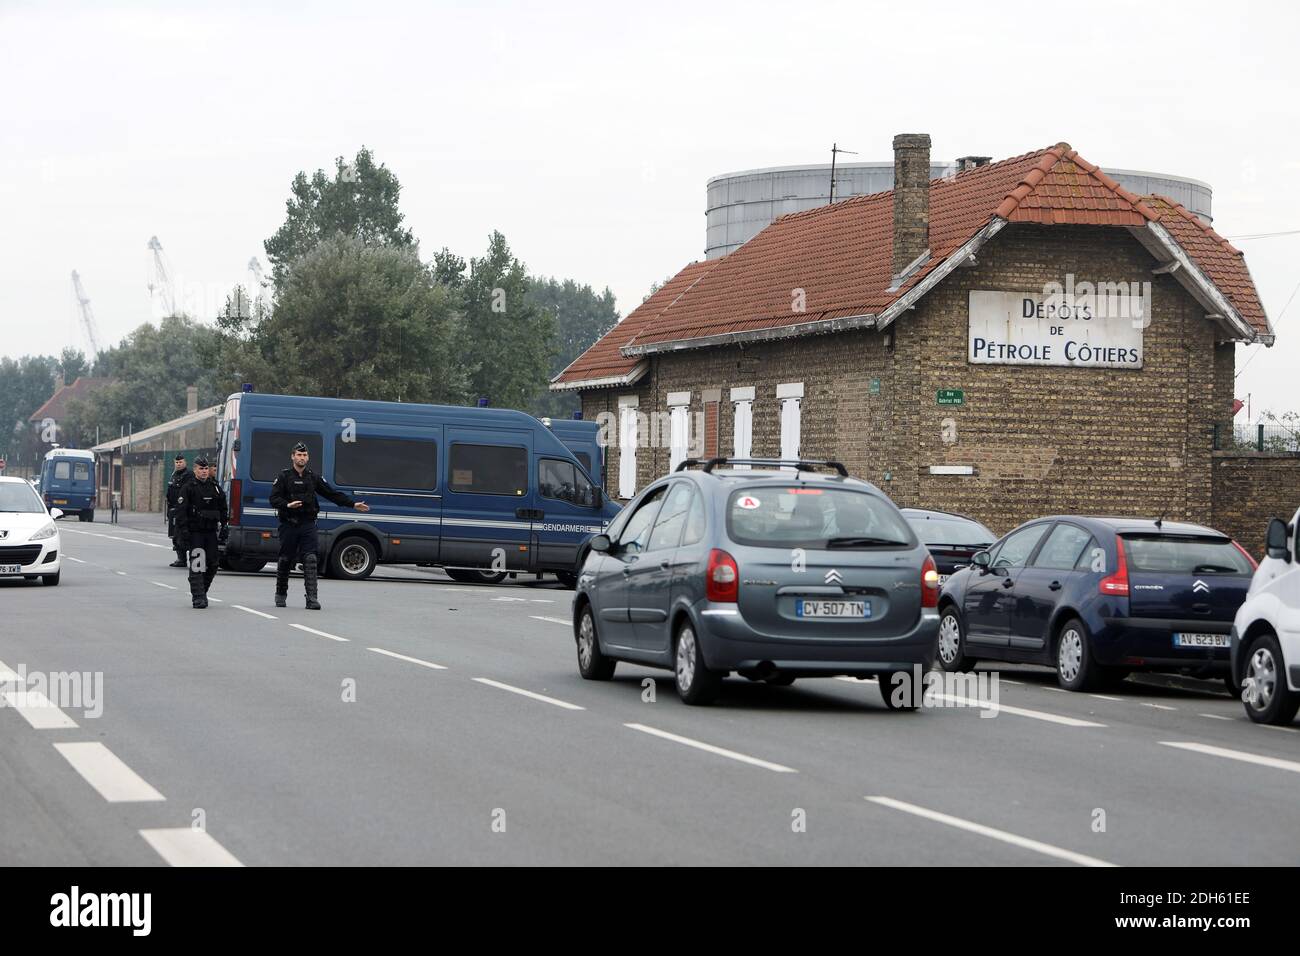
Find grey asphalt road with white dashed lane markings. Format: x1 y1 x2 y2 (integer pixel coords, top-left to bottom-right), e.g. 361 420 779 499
0 522 1300 866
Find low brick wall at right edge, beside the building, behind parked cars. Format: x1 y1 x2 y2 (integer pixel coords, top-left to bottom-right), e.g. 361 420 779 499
1210 451 1300 561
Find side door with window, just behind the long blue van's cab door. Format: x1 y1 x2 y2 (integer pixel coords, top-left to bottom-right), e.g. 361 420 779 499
439 425 537 571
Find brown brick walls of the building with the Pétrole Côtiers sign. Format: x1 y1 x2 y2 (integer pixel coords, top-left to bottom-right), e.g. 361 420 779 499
582 225 1234 533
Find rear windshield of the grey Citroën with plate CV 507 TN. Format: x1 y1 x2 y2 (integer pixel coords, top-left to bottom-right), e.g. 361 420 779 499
727 485 917 550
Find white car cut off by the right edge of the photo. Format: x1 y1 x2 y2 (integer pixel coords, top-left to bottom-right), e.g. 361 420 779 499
1232 511 1300 724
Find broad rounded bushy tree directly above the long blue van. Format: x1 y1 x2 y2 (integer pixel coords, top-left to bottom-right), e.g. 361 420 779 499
248 235 468 403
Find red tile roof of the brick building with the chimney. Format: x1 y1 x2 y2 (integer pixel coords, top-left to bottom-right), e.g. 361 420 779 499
555 143 1269 384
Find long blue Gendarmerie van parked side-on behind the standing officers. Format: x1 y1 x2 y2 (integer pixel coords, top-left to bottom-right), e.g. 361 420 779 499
217 392 619 585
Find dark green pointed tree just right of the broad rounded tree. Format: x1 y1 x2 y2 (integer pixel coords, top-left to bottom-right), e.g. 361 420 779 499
454 232 556 408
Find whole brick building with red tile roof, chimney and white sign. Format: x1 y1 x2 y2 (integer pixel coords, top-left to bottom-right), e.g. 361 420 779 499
551 134 1279 546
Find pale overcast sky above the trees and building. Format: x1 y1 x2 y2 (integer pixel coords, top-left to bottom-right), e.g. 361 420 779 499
0 0 1300 421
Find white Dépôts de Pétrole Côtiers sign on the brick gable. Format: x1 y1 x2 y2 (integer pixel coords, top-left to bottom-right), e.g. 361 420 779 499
966 291 1149 368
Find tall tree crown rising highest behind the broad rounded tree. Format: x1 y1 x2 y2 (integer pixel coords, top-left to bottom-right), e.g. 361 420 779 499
263 146 416 289
